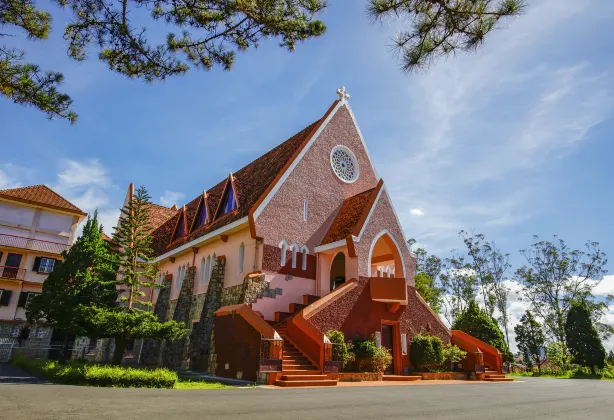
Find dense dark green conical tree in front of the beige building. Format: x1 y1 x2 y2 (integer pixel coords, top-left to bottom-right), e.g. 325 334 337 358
26 212 117 354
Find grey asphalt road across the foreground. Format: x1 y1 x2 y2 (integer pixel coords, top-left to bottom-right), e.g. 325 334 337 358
0 364 614 420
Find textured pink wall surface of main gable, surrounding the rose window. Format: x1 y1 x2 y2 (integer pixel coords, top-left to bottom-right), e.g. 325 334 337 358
256 106 378 253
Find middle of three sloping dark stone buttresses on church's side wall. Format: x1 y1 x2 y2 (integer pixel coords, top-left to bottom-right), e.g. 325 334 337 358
162 267 196 369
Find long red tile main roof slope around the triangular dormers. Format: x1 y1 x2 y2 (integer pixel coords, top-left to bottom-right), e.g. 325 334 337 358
153 120 321 255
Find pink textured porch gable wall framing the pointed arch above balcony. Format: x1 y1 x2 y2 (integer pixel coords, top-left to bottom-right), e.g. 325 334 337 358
355 190 416 286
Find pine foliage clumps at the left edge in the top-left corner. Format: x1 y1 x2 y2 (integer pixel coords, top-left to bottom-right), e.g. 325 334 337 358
0 0 77 122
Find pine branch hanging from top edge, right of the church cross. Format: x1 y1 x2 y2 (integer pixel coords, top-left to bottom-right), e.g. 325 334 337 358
367 0 524 72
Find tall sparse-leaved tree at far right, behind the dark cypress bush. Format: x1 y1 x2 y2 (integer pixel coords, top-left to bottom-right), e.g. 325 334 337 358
516 236 612 344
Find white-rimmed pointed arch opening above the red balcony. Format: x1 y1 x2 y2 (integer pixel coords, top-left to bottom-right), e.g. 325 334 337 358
369 230 405 278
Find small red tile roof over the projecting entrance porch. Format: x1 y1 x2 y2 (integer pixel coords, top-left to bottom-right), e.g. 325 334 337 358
321 180 383 245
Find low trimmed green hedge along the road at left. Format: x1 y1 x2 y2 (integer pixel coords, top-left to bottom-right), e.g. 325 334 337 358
12 355 178 388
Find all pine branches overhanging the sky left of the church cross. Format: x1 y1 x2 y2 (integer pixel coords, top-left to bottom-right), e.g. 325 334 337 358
0 0 326 122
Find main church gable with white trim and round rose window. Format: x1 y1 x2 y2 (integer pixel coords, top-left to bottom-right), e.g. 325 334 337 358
254 100 378 252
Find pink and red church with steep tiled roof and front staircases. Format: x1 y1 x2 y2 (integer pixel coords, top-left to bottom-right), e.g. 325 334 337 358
132 88 501 386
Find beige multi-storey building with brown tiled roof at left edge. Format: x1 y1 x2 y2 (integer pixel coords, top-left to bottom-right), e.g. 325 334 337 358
0 185 86 338
